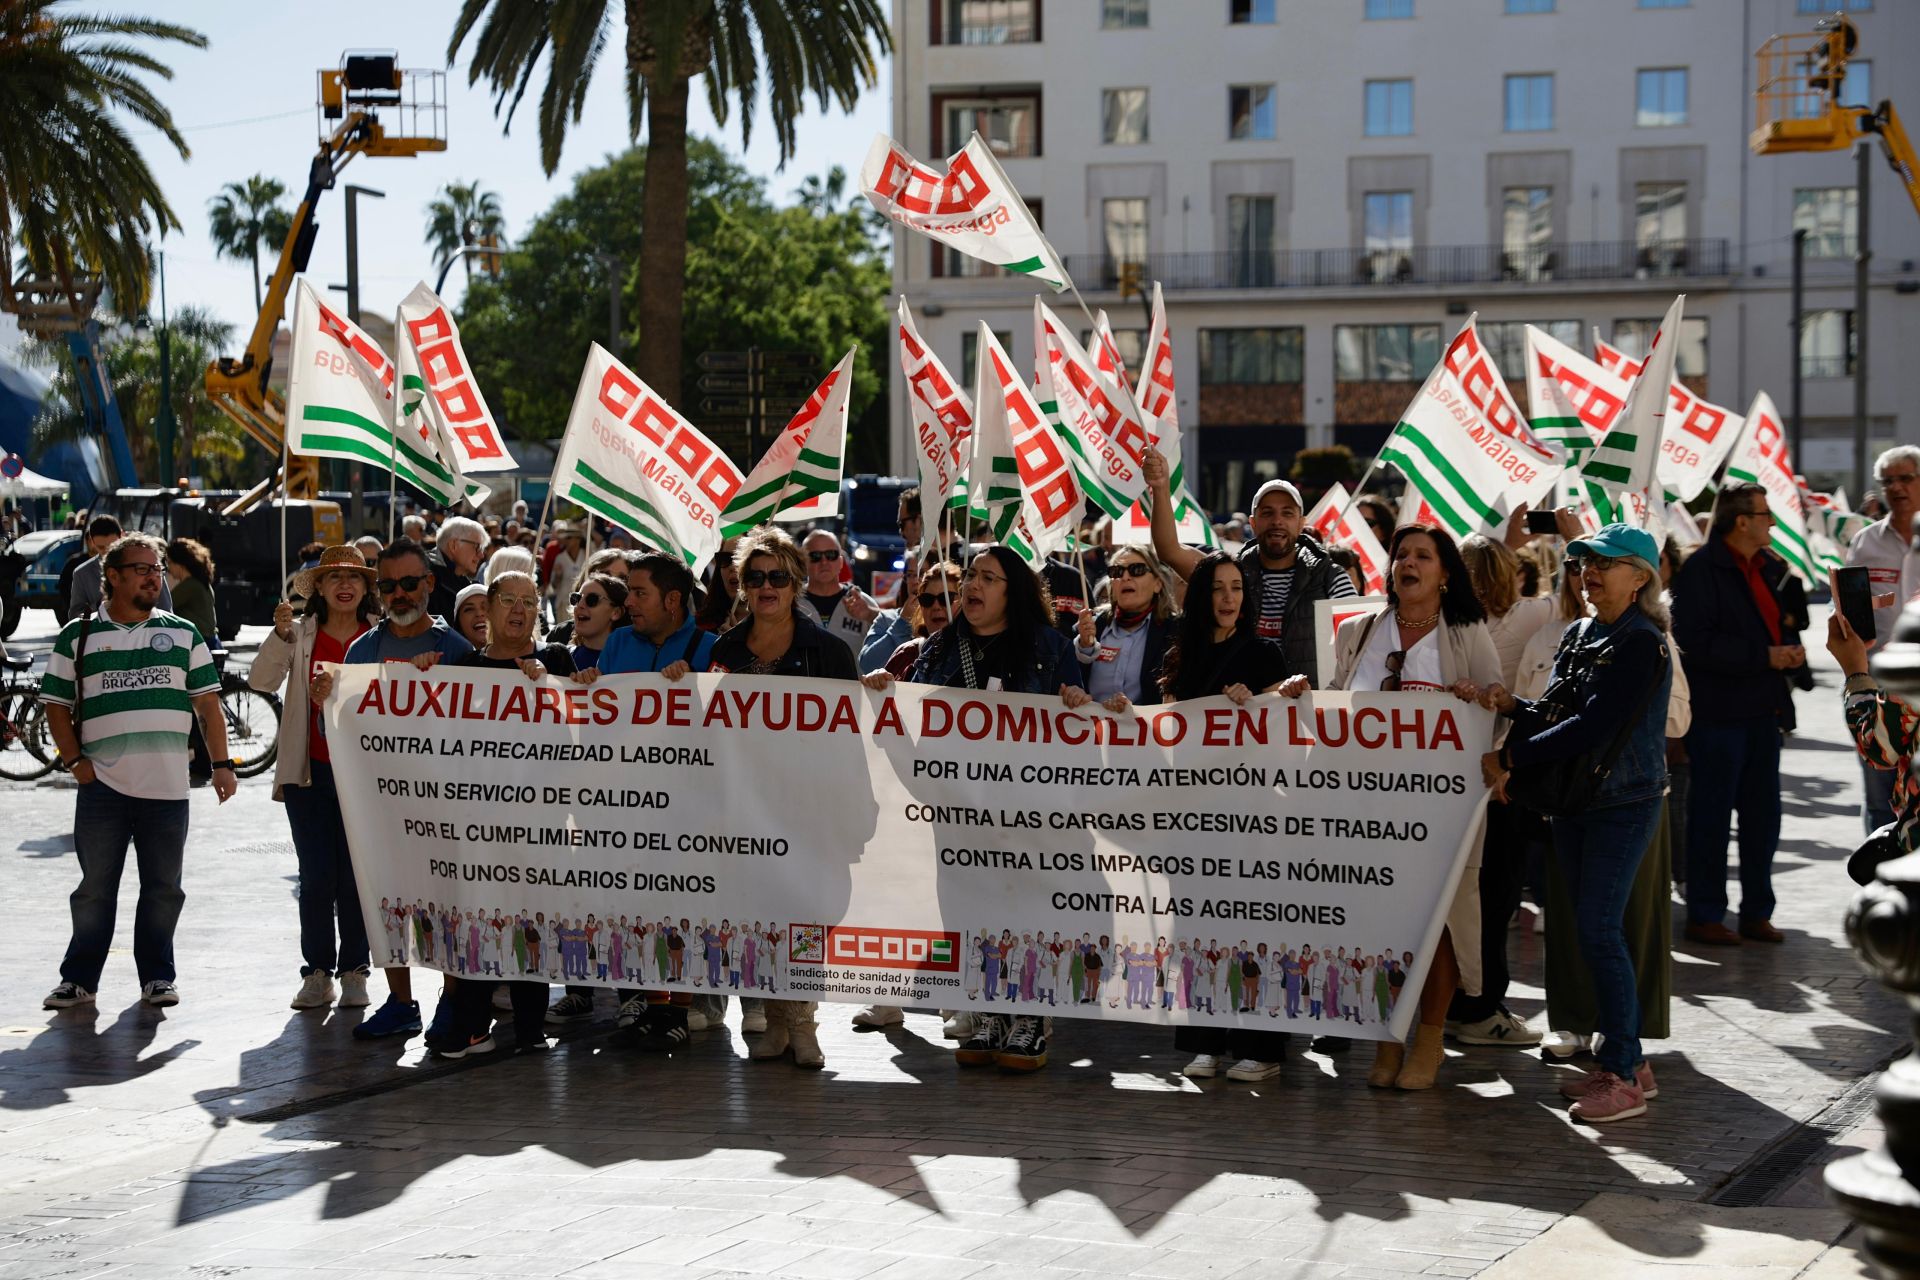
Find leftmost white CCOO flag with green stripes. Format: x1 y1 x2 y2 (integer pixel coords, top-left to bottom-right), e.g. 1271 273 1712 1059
286 280 488 505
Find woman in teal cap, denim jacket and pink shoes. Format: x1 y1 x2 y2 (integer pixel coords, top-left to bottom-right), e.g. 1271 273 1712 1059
1482 524 1672 1125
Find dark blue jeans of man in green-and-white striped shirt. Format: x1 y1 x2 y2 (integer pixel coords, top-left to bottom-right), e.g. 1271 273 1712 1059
60 781 186 990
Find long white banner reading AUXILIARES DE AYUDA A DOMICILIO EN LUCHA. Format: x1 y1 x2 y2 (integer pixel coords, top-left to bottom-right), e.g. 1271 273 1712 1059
324 664 1492 1038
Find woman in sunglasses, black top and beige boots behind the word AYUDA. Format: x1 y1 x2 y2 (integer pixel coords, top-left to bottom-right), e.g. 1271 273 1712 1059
707 526 858 1071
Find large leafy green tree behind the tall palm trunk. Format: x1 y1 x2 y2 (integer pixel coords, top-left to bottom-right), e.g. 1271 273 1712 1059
461 138 891 470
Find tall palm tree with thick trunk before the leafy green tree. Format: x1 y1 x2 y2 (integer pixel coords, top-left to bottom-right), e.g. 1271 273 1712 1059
447 0 893 401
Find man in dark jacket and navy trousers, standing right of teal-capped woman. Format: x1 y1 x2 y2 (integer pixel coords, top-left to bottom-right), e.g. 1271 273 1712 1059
1672 484 1811 946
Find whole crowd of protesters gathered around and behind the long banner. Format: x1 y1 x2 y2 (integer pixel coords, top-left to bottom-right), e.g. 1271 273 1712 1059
33 447 1920 1123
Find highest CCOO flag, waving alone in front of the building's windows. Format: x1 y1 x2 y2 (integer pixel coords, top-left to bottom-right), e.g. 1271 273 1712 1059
860 132 1068 294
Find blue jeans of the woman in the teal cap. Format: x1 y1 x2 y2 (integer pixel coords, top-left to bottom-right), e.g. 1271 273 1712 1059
1553 796 1661 1080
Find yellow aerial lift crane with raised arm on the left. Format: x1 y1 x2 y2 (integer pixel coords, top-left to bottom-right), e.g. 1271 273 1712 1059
205 50 447 514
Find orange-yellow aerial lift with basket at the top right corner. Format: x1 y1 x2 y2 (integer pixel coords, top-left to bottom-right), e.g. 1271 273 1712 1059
1747 17 1920 213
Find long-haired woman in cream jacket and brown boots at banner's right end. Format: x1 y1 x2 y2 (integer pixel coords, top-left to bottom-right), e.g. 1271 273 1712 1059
1281 524 1505 1090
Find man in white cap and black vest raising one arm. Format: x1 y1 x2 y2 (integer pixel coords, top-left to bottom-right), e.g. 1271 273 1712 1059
1140 449 1354 687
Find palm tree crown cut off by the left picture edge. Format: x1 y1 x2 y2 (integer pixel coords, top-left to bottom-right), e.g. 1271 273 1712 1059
0 0 207 313
